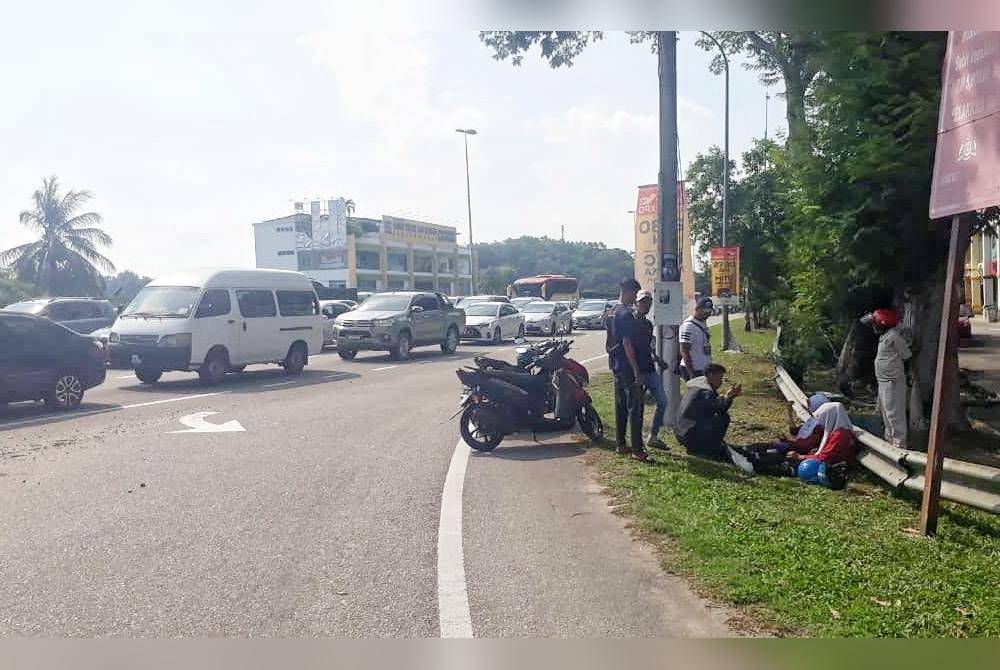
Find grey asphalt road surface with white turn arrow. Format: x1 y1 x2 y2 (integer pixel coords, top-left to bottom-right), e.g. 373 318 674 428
0 322 729 637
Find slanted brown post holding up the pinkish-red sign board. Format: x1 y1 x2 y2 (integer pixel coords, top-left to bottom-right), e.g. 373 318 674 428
920 214 969 535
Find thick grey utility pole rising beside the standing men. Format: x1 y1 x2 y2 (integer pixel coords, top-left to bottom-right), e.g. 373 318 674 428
656 30 681 426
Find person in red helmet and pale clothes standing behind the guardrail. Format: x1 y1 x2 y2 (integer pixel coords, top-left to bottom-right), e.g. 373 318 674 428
862 309 913 449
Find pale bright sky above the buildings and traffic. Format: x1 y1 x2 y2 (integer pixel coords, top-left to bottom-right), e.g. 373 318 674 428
0 0 784 275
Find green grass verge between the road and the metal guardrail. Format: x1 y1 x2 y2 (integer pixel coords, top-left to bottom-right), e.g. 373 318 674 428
592 327 1000 637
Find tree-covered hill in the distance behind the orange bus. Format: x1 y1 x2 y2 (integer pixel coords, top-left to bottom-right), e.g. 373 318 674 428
476 236 635 296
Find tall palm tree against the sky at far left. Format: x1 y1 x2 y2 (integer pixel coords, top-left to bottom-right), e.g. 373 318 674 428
0 176 115 295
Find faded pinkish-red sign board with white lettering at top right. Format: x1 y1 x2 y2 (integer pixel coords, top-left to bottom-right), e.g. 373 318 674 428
930 30 1000 219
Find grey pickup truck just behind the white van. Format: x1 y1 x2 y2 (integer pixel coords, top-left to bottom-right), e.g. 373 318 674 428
334 291 465 360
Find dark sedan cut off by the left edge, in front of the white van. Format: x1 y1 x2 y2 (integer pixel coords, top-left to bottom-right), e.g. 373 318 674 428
0 311 107 409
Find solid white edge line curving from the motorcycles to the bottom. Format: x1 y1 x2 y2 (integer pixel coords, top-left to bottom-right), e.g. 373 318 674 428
438 440 472 638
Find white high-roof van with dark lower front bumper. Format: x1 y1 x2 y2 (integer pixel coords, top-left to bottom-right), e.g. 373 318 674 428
108 270 323 384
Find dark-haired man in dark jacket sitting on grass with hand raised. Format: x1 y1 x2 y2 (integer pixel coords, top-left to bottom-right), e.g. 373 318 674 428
676 363 741 461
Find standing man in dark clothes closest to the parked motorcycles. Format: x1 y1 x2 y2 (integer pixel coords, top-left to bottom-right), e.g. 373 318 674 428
606 277 650 463
